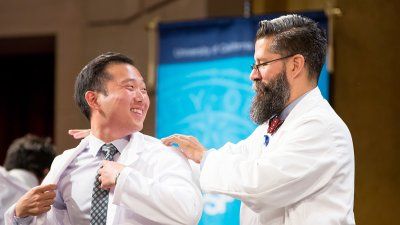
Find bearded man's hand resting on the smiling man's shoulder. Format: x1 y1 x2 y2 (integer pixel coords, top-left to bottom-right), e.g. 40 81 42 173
161 134 206 163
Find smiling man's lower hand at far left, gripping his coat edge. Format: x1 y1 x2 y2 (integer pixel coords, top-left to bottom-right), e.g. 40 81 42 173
15 184 57 217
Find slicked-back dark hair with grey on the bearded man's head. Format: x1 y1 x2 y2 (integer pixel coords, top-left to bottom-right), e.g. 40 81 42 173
256 15 327 81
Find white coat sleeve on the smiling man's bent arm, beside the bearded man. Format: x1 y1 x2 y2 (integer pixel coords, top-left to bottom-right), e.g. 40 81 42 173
113 148 203 225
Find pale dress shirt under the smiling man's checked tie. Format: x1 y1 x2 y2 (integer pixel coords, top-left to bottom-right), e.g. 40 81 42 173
16 134 129 225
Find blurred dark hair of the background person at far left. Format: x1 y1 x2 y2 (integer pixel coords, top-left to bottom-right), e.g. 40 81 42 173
4 134 56 180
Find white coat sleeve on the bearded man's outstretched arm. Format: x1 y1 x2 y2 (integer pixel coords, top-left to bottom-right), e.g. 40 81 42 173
200 118 337 212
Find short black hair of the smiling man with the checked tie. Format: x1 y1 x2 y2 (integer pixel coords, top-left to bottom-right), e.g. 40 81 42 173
74 52 133 119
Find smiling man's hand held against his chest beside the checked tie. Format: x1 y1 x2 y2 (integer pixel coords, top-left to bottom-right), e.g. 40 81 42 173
99 160 125 190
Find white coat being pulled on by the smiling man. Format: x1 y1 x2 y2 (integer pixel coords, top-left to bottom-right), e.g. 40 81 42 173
5 132 202 225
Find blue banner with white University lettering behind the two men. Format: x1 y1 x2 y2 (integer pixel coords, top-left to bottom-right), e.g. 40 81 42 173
156 12 329 225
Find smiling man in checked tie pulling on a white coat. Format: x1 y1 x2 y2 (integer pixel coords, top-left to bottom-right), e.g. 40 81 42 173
6 53 202 225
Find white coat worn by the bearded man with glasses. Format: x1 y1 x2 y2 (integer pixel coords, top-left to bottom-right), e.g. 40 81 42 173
200 88 355 225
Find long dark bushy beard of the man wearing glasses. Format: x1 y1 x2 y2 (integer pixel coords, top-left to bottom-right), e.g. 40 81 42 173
250 70 290 125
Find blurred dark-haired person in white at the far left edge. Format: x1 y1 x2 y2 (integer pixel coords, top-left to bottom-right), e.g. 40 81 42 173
0 134 56 224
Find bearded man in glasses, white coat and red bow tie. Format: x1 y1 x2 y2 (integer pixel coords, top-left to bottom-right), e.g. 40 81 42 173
163 15 355 225
